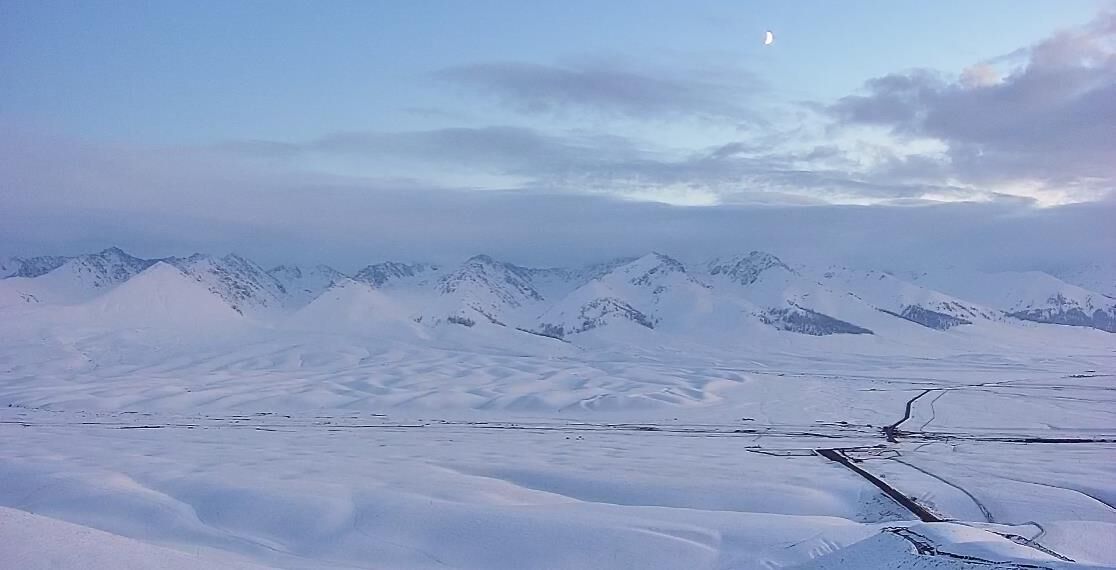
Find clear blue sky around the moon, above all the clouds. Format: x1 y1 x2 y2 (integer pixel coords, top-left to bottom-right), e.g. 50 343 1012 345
0 0 1103 143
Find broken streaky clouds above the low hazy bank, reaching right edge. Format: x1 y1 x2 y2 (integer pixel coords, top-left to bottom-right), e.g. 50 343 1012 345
203 15 1116 205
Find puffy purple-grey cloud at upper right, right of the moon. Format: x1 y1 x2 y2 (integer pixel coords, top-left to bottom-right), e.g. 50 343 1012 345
828 12 1116 199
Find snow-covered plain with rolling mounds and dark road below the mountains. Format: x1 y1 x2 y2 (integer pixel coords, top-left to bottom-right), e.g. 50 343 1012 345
0 255 1116 570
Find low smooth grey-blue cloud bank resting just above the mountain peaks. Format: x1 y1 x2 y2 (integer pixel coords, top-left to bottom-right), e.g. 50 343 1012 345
0 130 1116 270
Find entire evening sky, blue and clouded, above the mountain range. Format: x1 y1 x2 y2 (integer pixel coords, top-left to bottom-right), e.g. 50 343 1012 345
0 0 1116 269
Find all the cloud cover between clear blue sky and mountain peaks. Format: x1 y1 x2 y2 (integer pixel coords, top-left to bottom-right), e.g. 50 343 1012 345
0 15 1116 269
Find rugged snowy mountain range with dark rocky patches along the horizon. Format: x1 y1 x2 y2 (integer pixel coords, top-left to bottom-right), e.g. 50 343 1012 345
0 248 1116 344
